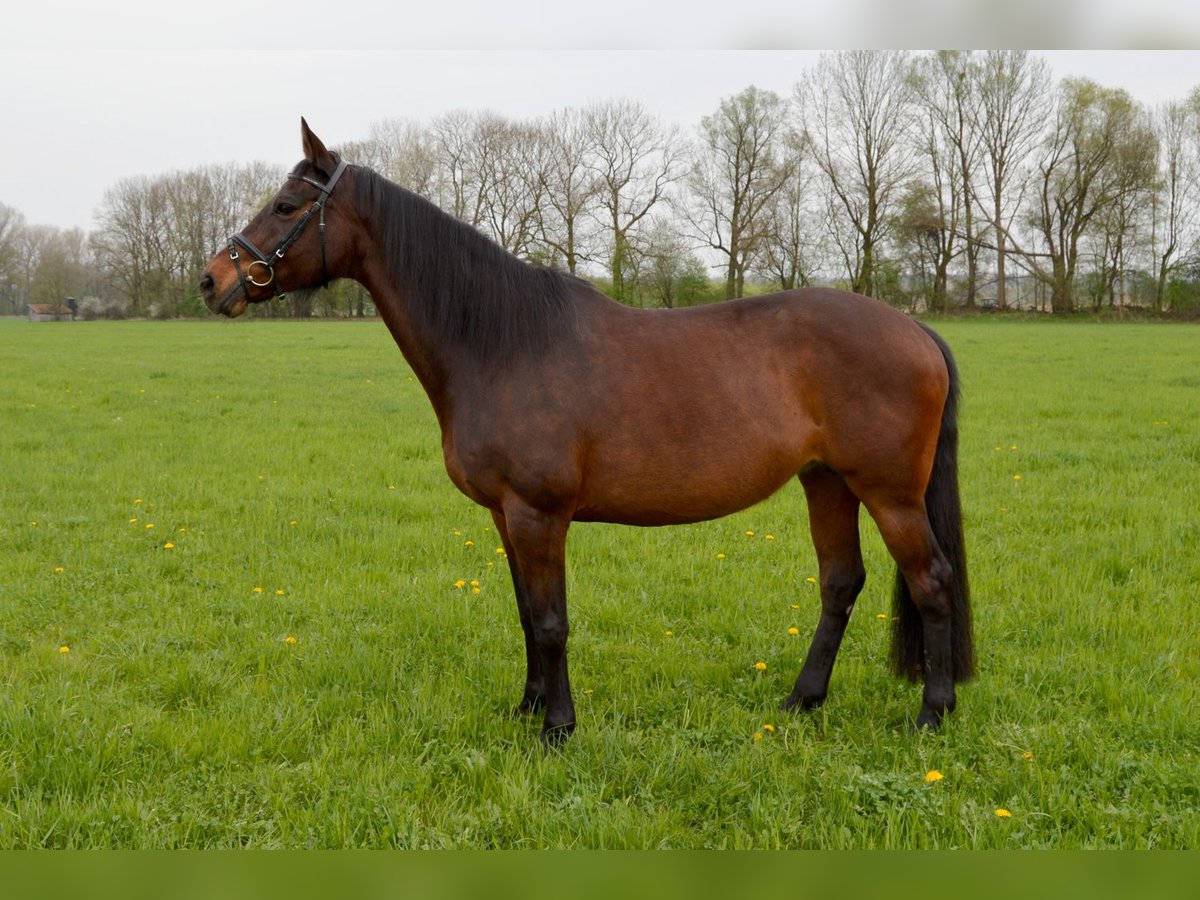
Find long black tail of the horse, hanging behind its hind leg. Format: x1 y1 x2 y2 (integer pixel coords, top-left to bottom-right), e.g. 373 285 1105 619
892 325 974 682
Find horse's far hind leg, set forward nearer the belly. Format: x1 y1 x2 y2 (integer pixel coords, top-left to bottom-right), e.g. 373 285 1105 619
784 467 866 709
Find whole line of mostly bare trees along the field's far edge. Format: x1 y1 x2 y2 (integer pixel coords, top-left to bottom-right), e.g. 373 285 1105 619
0 50 1200 316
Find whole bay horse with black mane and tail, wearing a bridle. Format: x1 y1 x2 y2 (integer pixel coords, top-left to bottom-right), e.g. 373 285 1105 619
200 119 974 745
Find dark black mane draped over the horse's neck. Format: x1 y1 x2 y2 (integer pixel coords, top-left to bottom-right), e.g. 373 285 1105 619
354 167 580 361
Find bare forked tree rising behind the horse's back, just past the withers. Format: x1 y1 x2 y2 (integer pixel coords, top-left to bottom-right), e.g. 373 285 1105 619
583 101 684 300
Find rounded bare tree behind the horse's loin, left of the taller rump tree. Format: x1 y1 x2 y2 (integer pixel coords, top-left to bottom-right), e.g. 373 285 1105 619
688 85 793 300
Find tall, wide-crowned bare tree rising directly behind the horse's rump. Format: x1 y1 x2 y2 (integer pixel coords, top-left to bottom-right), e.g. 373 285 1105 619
796 50 913 294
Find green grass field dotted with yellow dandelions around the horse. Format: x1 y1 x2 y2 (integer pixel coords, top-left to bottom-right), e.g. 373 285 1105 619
0 320 1200 848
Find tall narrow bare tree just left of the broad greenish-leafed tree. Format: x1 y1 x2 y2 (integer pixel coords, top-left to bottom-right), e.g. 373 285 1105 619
973 50 1050 310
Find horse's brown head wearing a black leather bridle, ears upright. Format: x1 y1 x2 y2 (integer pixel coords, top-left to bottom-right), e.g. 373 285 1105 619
200 119 349 318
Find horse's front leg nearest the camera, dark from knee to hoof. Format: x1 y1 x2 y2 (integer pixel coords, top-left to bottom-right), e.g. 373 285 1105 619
494 498 575 745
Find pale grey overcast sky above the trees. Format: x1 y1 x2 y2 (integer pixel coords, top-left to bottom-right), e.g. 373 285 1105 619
0 0 1200 229
